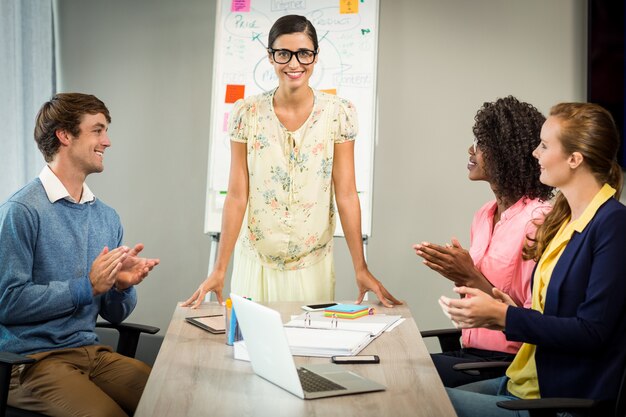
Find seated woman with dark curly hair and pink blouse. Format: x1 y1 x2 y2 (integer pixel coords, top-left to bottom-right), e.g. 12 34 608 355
414 96 552 387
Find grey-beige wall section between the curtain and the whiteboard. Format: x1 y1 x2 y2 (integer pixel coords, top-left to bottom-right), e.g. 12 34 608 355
55 0 215 348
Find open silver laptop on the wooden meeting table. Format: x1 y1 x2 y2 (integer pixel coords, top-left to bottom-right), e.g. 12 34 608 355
230 293 385 400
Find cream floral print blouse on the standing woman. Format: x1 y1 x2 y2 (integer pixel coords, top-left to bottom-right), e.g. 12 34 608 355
229 89 358 270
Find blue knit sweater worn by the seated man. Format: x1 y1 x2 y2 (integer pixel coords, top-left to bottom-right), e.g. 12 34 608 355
0 178 137 354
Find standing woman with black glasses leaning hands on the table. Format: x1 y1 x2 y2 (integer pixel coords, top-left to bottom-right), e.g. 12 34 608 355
183 15 400 307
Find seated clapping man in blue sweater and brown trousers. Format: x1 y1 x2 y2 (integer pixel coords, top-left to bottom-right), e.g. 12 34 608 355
0 93 159 417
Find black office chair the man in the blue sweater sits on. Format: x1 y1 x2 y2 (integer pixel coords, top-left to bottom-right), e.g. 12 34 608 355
0 322 160 417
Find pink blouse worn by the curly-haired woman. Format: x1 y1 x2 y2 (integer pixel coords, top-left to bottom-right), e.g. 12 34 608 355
462 197 550 354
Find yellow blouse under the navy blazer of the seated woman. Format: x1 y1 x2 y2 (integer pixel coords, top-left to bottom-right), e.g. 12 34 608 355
506 184 615 399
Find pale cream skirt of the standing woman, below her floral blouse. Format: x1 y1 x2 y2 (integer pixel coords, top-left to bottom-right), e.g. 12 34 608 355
230 242 335 303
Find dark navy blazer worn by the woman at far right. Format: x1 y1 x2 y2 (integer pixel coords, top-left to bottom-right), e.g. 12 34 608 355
505 198 626 400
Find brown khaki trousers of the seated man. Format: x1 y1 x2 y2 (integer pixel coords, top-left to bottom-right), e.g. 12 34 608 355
8 345 150 417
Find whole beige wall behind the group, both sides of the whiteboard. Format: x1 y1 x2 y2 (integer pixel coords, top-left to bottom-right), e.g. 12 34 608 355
56 0 586 346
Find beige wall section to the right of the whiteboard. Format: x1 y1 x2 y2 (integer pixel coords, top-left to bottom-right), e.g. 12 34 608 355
370 0 586 348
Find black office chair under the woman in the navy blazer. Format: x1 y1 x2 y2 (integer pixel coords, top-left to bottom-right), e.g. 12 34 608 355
497 365 626 417
